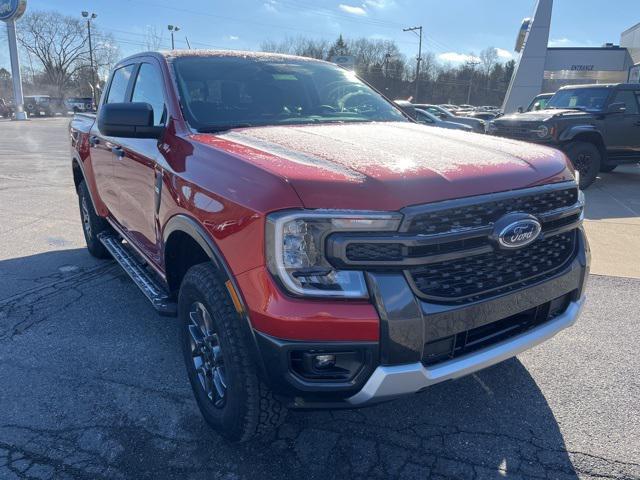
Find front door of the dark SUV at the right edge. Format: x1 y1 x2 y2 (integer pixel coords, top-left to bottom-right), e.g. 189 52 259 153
606 90 640 159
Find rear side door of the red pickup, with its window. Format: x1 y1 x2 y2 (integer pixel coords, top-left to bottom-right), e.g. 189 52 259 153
89 64 135 218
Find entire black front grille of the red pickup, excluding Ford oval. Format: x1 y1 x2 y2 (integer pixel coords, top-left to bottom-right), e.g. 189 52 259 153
325 182 583 304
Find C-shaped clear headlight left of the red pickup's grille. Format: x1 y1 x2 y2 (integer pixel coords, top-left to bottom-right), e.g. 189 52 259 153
266 210 402 298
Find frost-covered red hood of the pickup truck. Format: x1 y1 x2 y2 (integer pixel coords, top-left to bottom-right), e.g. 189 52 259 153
195 122 573 210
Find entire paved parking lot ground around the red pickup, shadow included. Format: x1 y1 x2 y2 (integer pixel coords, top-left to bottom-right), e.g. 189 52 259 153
0 119 640 480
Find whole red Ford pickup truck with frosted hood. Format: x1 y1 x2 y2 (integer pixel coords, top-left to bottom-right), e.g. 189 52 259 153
70 51 589 440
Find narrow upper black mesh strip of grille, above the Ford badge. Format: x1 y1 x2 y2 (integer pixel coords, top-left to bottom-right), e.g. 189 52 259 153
407 187 578 235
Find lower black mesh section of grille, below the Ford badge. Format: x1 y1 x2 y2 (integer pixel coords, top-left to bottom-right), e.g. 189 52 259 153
408 231 576 302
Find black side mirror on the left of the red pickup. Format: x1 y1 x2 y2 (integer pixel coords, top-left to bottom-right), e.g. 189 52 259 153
98 102 164 139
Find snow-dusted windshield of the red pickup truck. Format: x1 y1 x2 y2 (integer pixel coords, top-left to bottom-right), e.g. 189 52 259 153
172 55 407 132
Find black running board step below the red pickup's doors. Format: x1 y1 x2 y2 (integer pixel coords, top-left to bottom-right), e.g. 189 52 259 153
98 232 178 317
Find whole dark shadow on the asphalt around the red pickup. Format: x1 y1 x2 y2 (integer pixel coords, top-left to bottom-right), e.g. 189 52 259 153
0 249 579 480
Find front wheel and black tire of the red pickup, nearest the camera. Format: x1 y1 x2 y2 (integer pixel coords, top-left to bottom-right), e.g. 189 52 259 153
178 263 286 442
